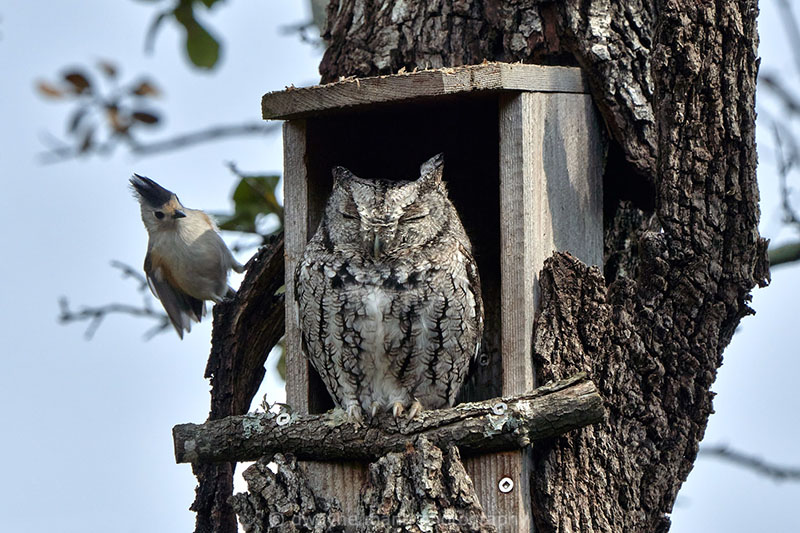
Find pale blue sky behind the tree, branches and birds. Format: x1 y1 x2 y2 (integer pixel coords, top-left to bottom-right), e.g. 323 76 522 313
0 0 800 533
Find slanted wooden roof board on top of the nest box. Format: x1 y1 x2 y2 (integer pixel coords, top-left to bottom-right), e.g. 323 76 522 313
261 63 588 119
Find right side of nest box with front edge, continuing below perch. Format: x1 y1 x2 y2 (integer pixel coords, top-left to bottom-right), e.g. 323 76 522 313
465 92 603 533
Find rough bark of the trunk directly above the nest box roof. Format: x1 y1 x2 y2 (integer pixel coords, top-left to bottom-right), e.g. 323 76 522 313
320 0 657 176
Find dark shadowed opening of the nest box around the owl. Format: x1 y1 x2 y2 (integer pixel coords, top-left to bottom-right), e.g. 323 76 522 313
306 95 501 413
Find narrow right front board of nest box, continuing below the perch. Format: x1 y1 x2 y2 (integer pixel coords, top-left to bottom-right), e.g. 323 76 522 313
466 93 540 533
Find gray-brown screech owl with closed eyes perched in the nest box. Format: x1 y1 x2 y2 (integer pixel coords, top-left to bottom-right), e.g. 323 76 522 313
294 154 483 421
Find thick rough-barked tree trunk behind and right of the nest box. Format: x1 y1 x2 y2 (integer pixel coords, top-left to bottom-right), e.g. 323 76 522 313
320 0 768 532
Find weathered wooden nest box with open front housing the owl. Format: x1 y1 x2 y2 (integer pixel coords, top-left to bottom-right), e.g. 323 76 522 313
262 63 605 532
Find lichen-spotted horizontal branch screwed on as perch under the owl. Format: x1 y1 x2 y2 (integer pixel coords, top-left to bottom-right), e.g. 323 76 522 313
173 373 605 464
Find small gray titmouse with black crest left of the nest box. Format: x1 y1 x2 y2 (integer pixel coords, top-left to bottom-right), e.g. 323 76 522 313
130 174 244 338
